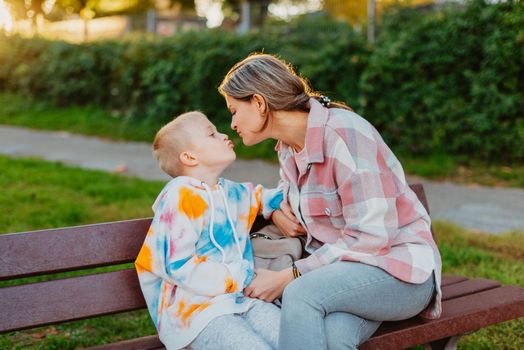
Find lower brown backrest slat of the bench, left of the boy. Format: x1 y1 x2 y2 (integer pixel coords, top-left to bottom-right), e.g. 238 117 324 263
0 269 146 332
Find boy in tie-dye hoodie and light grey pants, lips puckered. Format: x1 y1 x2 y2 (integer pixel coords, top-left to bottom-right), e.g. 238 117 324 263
135 112 282 349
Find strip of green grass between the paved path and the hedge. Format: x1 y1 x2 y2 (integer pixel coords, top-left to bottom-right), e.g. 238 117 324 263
0 92 524 188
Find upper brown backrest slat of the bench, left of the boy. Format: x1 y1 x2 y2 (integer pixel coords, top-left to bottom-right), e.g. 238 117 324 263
0 218 151 280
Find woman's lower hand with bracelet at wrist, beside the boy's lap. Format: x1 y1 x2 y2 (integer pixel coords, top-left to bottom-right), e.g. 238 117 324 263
244 267 293 302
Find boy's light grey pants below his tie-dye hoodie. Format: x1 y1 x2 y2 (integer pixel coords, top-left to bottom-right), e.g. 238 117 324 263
190 300 280 350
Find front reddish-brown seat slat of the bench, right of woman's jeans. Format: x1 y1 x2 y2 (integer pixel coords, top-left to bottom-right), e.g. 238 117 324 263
359 286 524 350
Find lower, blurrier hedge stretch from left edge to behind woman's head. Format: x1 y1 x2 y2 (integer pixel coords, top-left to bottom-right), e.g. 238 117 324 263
0 17 369 127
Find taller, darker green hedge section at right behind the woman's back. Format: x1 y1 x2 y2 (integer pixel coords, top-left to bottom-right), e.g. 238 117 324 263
361 1 524 162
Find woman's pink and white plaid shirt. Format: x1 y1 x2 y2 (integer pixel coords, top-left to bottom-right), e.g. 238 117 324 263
276 99 442 318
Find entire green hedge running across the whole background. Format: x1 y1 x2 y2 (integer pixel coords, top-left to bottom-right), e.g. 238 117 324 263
0 0 524 162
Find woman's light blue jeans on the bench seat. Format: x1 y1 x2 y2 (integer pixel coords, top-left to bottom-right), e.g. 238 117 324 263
278 262 435 350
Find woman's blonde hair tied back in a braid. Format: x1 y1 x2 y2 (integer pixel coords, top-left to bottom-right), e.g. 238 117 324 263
218 54 351 130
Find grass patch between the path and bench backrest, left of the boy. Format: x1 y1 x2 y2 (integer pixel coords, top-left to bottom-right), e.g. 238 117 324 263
0 156 163 233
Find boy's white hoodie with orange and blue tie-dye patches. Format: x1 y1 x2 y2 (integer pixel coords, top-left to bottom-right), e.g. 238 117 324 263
135 176 282 349
